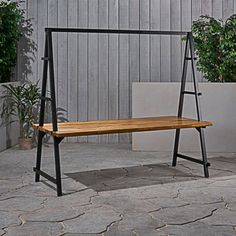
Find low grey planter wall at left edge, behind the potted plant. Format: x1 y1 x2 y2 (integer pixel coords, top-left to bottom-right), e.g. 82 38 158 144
0 82 20 151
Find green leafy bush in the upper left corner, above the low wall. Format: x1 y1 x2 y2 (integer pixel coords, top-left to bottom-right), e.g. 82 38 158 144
0 0 37 83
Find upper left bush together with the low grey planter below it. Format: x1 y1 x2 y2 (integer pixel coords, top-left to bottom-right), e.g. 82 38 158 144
0 0 37 151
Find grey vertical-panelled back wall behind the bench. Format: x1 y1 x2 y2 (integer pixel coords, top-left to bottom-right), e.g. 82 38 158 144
18 0 236 143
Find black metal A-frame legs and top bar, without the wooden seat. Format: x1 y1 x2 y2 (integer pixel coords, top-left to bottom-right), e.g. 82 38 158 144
33 28 210 196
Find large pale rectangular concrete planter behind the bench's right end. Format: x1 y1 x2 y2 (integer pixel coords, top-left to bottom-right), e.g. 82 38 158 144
132 83 236 152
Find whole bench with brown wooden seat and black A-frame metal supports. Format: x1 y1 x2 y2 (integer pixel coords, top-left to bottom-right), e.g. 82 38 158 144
33 28 212 196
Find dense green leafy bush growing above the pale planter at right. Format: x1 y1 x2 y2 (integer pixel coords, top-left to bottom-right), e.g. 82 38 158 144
192 15 236 82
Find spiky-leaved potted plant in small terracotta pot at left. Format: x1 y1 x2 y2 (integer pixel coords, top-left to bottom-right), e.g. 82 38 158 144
1 83 40 149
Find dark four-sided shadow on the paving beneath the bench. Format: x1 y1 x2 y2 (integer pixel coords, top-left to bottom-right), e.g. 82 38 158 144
65 163 201 192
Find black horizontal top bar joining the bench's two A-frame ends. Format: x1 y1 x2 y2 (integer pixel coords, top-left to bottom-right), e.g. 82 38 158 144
45 28 190 35
